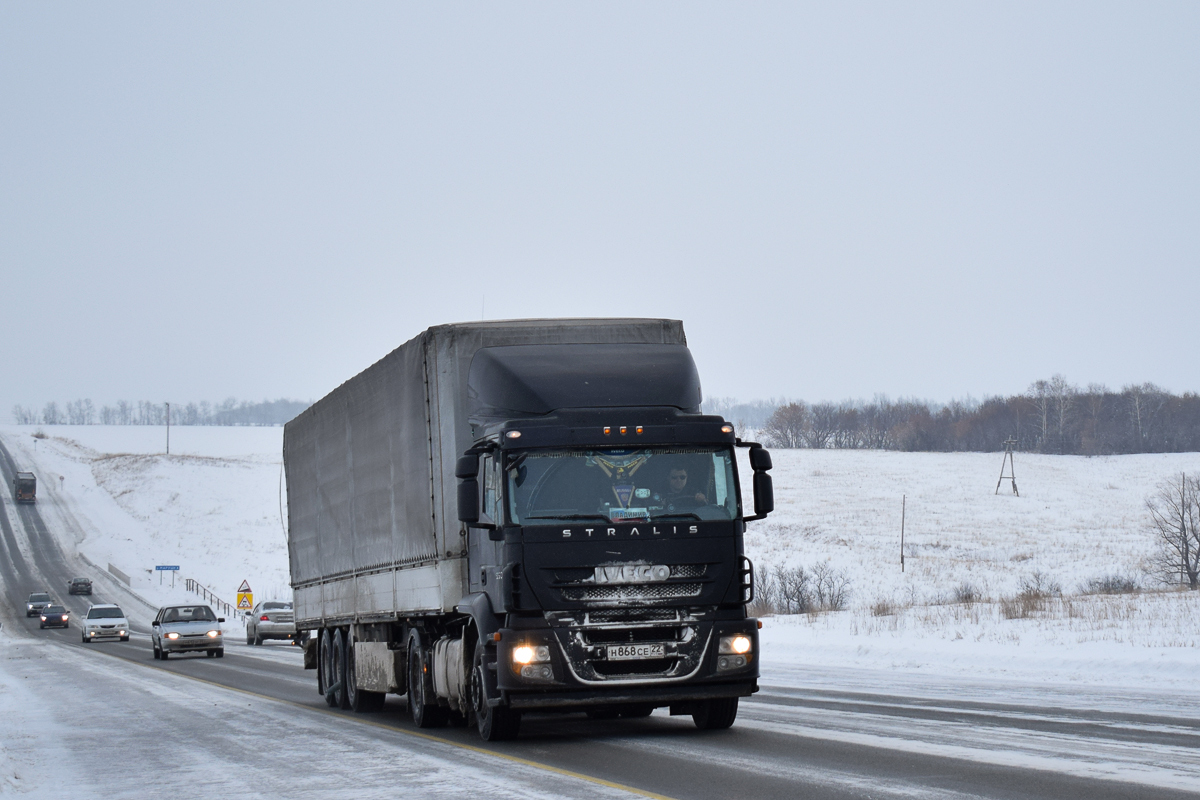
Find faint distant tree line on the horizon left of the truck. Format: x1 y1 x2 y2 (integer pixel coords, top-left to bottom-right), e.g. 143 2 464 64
12 397 311 426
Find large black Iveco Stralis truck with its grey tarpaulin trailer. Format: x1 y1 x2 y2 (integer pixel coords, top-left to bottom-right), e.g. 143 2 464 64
283 319 774 740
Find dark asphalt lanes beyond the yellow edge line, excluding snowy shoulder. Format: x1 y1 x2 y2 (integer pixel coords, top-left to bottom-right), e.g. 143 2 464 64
0 445 1200 800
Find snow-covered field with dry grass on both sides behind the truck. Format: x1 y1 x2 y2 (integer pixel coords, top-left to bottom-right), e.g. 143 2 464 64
0 426 1200 688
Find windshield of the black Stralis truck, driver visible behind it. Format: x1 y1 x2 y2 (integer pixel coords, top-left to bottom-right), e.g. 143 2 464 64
506 447 738 524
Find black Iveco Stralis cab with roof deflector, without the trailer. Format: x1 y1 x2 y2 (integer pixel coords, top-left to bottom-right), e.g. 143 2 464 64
456 344 773 727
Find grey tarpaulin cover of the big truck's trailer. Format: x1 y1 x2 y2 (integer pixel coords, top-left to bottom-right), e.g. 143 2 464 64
283 319 698 627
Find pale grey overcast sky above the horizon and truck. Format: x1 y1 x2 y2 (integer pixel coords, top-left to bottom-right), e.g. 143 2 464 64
0 1 1200 420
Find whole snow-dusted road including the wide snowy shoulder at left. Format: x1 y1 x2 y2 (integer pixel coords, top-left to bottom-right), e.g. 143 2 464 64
0 441 1200 800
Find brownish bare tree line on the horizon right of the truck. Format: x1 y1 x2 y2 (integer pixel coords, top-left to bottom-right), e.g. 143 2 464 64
758 375 1200 456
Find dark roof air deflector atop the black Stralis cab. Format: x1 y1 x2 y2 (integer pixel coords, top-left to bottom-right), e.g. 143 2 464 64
467 344 701 419
